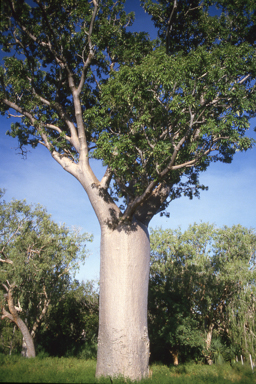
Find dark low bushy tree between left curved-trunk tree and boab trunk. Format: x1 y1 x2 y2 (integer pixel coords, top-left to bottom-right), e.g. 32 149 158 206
37 281 99 359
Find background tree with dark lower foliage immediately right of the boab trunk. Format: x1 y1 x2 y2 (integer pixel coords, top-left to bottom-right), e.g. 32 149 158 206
149 224 213 365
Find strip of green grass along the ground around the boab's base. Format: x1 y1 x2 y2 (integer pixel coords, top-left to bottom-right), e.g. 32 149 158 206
0 355 256 384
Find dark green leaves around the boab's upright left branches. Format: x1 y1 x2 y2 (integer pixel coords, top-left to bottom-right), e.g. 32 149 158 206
1 0 149 159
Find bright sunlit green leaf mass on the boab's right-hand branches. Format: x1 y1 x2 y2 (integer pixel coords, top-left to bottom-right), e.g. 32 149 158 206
93 45 255 197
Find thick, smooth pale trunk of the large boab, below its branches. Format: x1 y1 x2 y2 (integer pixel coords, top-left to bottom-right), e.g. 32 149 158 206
96 222 150 380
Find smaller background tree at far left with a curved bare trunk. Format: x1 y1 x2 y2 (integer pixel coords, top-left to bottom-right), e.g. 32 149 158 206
0 190 91 357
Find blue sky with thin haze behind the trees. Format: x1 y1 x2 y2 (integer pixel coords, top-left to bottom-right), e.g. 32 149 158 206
0 0 256 280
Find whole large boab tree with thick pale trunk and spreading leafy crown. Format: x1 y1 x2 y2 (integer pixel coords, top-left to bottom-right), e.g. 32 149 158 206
0 0 255 379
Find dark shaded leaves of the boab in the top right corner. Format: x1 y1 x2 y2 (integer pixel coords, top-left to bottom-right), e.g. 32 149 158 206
141 0 256 55
